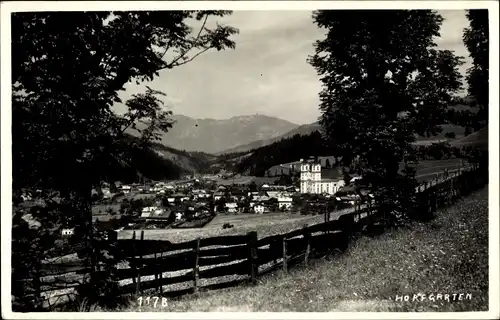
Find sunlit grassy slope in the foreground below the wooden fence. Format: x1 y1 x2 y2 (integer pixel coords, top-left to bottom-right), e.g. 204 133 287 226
123 188 488 312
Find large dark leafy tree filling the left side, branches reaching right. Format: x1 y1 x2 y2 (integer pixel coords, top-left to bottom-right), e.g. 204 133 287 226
12 11 237 310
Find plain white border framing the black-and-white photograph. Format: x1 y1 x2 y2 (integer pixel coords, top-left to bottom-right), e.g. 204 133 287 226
0 1 500 319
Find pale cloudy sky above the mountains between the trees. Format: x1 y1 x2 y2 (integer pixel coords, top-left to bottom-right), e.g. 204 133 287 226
117 10 471 124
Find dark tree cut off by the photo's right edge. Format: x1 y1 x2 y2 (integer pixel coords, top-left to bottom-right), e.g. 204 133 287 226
463 9 490 130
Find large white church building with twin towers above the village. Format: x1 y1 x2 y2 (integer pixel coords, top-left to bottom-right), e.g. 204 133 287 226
300 159 345 194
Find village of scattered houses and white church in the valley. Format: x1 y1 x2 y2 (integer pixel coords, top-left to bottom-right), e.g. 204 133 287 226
87 157 360 235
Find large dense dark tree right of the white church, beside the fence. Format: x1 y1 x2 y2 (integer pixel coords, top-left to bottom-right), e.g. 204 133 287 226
309 10 462 225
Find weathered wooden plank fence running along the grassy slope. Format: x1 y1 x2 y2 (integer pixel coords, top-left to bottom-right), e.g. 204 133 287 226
12 162 488 308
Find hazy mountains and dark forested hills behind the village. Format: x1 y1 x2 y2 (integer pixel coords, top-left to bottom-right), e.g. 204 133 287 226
122 105 484 180
